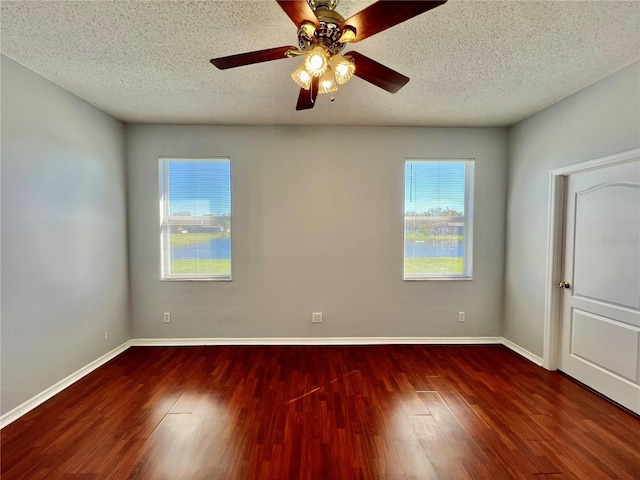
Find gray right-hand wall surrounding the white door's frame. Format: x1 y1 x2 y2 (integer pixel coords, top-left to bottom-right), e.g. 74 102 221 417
503 62 640 356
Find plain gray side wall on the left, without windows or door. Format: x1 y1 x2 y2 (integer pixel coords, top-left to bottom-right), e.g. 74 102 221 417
1 56 130 413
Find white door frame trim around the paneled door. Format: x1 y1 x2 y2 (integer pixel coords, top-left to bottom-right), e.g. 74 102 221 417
542 148 640 370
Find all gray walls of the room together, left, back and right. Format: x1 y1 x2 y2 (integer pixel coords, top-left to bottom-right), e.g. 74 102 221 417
1 51 640 413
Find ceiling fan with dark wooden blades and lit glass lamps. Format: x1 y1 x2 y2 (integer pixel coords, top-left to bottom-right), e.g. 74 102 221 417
211 0 447 110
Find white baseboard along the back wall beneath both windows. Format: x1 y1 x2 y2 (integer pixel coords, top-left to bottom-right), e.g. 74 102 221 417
131 337 503 347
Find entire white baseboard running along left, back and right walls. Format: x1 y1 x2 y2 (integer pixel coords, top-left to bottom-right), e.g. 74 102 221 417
0 337 542 429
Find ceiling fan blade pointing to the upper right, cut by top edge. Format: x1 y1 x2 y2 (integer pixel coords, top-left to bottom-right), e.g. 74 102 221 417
342 0 447 42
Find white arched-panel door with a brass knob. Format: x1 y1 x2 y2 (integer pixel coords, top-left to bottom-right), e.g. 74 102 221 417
558 159 640 414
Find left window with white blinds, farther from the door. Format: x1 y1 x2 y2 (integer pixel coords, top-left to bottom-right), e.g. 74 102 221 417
160 158 231 280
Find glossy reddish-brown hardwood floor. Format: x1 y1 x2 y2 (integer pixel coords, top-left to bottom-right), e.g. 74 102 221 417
1 345 640 480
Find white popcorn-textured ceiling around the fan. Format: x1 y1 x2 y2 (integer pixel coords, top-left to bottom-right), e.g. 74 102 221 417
1 0 640 126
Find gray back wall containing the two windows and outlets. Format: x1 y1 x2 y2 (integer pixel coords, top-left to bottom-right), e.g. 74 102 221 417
126 125 507 338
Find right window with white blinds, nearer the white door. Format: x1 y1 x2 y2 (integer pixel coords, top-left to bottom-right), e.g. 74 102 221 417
404 160 474 280
